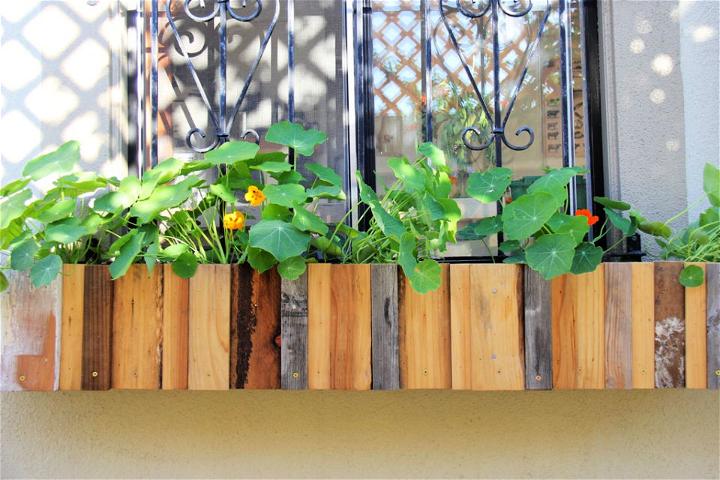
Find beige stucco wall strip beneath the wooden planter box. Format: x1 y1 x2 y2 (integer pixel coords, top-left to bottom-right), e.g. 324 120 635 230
0 390 720 478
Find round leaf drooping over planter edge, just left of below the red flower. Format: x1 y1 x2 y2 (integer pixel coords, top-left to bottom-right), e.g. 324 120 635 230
525 233 575 280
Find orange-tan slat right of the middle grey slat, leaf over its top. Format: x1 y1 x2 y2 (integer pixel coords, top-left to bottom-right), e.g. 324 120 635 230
398 265 452 389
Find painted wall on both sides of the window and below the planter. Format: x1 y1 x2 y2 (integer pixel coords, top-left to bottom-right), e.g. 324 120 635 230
0 0 720 478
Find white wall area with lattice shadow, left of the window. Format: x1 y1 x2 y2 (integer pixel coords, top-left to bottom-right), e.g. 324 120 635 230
0 0 127 183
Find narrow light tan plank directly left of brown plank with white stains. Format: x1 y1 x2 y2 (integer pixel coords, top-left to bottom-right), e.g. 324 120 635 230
631 262 655 388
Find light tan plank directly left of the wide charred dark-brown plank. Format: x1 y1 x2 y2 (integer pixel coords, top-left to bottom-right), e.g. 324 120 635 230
188 265 231 390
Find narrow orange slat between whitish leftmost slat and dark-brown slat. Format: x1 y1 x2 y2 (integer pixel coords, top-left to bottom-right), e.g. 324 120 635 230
60 265 85 390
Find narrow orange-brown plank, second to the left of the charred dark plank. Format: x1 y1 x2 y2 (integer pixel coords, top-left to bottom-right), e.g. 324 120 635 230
162 265 188 390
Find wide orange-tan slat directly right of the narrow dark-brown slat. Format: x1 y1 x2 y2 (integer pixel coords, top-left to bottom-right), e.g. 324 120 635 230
112 265 162 390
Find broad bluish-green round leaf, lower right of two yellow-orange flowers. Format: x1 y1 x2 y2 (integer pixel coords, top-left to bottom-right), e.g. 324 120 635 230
250 220 310 262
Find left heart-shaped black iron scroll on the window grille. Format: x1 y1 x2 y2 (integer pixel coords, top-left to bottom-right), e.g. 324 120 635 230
161 0 280 153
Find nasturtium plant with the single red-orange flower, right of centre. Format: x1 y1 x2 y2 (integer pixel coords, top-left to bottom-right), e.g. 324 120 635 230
462 167 640 279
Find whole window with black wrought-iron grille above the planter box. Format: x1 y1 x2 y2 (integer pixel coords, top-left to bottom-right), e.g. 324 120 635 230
129 0 602 257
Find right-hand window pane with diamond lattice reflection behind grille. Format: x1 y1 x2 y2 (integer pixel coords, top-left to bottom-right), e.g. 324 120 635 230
372 0 585 256
